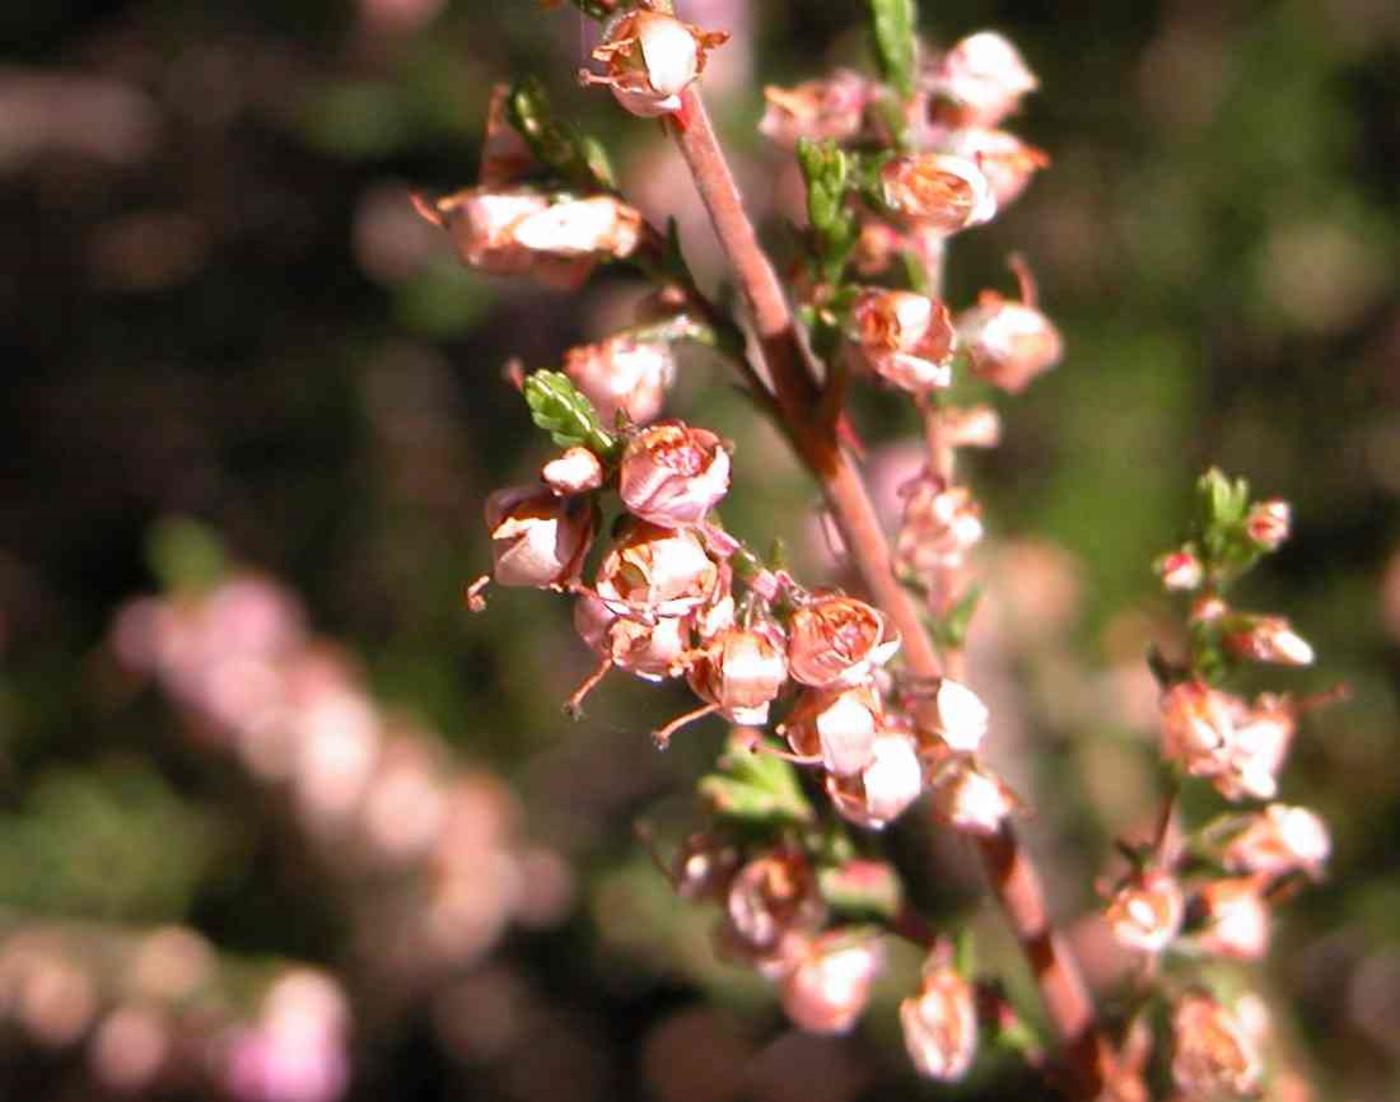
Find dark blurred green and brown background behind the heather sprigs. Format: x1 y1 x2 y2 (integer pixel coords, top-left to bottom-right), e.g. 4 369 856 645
0 0 1400 1102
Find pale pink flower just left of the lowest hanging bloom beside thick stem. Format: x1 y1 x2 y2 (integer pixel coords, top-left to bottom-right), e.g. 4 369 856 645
778 930 885 1033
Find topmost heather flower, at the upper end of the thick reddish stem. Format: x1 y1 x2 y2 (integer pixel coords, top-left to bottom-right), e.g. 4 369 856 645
578 8 729 118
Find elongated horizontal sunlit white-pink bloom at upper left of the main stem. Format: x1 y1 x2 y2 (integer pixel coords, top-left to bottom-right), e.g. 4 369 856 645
419 188 641 287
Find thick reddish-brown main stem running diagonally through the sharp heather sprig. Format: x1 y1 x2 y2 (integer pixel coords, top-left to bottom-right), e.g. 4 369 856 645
671 87 1110 1099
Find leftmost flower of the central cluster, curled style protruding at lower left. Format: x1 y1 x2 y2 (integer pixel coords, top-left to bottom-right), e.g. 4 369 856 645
486 486 596 587
